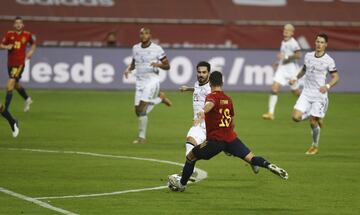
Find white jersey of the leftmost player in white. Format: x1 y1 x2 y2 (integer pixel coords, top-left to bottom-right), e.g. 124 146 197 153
132 42 166 80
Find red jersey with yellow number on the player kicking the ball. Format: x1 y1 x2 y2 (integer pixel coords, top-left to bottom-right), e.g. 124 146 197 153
205 91 237 143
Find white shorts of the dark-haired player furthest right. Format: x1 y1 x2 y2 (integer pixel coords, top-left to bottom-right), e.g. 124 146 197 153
294 93 329 118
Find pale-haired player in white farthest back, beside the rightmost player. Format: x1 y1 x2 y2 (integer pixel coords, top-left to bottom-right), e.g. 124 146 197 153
262 24 301 120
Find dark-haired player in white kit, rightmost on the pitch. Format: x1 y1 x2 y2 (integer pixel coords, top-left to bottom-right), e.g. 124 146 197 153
290 33 339 155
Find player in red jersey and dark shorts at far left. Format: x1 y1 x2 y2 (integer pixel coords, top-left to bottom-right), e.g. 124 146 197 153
0 17 36 112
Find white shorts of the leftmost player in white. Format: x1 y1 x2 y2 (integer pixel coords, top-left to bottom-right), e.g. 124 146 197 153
135 79 160 106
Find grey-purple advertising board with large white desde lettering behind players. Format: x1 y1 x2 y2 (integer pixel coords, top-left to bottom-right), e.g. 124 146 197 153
0 47 360 92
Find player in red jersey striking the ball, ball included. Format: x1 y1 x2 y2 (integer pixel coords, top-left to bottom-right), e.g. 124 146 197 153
168 71 289 192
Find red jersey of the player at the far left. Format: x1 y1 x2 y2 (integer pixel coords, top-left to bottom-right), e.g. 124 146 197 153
2 31 35 67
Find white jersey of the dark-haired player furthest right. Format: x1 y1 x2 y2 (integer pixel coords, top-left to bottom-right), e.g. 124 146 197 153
303 52 336 98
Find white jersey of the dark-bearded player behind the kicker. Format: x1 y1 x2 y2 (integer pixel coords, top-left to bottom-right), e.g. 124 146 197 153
193 81 211 119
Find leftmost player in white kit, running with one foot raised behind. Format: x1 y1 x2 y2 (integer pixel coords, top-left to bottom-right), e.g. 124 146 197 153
124 28 172 143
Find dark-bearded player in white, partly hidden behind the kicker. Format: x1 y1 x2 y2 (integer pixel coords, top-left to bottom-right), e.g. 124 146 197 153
180 61 211 156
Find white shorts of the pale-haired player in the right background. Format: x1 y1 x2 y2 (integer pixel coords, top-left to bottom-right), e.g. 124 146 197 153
273 63 299 90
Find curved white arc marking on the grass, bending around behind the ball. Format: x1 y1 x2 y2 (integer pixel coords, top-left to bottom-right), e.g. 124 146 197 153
2 148 207 200
